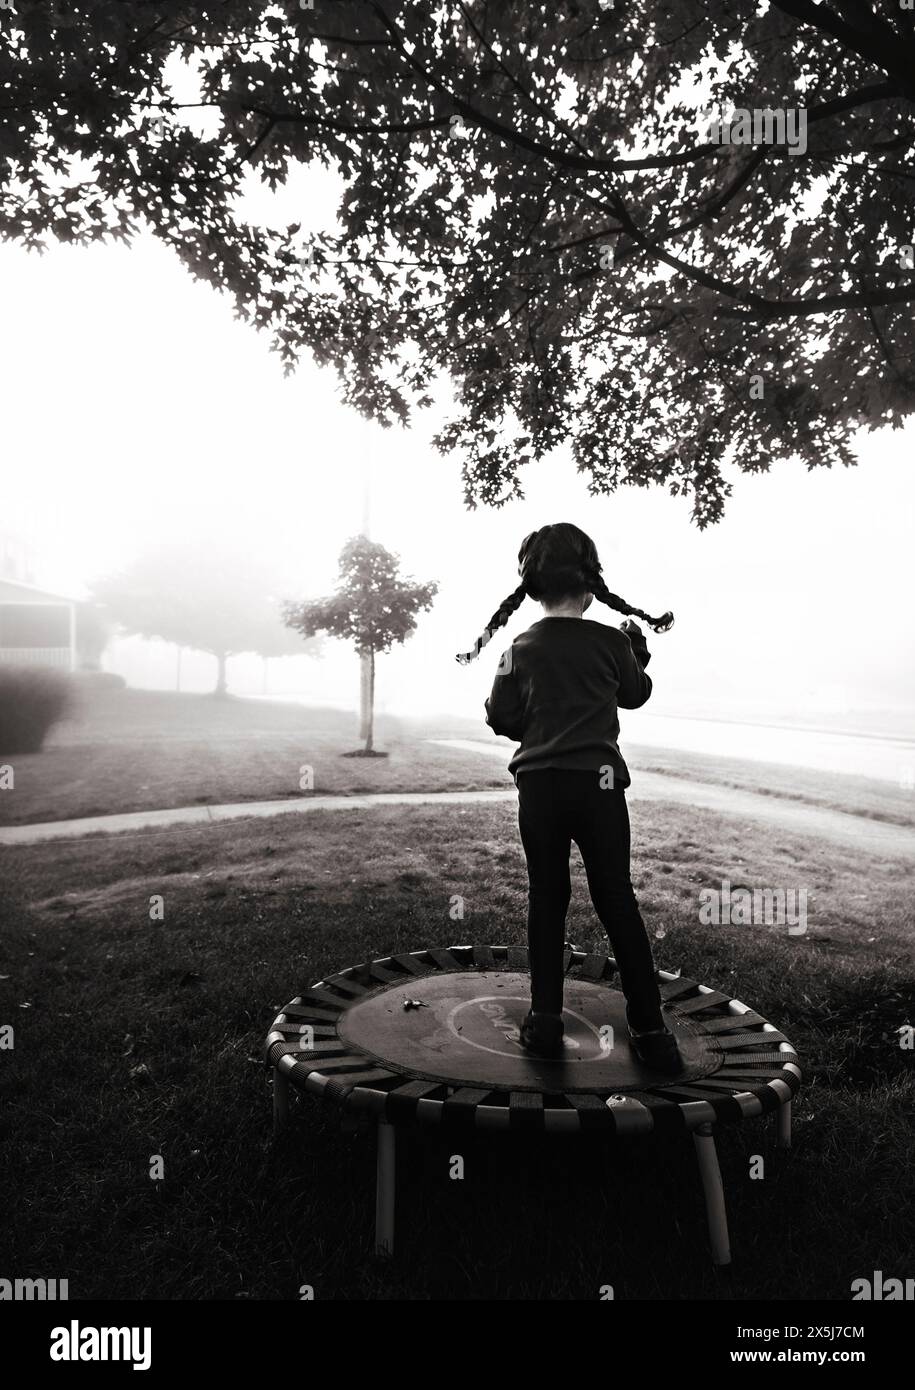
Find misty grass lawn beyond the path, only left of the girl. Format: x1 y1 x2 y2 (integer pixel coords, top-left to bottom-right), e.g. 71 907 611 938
0 689 508 824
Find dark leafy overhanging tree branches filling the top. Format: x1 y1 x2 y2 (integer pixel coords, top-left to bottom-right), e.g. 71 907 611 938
0 0 915 524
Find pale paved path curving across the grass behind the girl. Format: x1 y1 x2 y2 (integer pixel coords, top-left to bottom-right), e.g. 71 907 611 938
0 738 915 859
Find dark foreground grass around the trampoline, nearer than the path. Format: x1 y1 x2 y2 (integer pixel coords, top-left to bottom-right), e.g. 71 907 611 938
0 795 915 1300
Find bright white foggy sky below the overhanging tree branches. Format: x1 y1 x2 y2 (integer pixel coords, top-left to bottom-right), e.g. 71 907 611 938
0 204 915 731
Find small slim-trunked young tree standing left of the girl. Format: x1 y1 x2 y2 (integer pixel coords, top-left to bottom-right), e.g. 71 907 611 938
284 535 438 758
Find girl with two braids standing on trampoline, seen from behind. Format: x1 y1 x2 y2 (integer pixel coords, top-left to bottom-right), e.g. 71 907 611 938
458 521 680 1072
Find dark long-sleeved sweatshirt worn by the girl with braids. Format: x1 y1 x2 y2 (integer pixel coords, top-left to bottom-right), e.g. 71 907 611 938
485 617 651 787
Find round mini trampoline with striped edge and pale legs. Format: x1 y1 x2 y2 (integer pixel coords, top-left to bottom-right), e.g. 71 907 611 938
266 947 801 1265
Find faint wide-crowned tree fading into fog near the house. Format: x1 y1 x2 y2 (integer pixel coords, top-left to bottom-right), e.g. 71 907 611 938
93 542 321 695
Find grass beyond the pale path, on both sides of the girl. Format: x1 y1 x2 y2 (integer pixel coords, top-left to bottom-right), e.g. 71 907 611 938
0 689 915 824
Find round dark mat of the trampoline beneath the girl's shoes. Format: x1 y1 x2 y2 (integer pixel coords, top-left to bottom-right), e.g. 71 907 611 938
337 970 723 1094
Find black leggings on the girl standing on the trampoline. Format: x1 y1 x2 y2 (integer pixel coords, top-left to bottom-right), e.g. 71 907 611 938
517 767 663 1029
